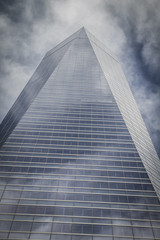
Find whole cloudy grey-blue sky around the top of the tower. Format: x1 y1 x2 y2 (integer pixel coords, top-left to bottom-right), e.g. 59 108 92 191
0 0 160 154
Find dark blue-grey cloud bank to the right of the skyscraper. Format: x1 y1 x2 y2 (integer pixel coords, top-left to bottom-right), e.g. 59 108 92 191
102 0 160 157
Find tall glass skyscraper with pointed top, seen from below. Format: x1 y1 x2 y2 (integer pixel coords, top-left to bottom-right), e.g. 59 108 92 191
0 28 160 240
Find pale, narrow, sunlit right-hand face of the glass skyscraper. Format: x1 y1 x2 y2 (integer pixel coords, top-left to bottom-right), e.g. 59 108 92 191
88 28 160 200
